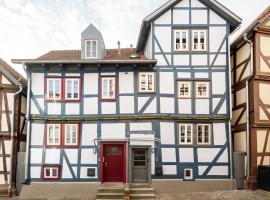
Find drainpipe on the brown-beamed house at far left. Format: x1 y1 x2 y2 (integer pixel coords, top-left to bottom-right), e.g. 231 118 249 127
8 82 23 197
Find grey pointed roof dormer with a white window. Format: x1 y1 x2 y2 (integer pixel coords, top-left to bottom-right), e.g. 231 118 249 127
81 24 106 59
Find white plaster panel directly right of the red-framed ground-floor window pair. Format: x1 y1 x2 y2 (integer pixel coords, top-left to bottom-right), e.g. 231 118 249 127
81 123 97 146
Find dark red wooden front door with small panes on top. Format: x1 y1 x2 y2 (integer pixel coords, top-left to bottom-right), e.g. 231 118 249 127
103 144 126 182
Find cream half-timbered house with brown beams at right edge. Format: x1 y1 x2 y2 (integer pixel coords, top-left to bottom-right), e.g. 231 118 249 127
231 7 270 188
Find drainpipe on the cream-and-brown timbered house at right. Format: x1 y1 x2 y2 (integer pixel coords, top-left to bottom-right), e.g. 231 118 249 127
243 33 253 180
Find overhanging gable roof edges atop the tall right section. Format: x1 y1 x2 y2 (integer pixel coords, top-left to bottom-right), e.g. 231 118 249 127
136 0 242 52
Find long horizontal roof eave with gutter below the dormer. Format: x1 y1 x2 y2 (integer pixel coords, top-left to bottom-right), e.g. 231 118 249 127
11 59 157 65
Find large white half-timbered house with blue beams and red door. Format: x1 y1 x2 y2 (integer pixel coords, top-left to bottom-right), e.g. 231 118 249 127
13 0 241 193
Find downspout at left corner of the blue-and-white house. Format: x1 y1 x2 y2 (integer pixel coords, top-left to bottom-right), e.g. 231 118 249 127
23 64 31 183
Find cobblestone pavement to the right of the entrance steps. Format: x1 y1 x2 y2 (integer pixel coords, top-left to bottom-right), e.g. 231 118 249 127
157 190 270 200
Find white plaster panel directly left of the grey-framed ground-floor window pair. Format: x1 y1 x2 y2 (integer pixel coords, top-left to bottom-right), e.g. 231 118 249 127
160 122 175 144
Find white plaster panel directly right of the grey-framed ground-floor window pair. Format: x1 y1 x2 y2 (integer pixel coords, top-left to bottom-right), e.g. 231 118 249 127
213 123 227 145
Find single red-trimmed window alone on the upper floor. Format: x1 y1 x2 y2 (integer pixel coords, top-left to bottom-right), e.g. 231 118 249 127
101 76 116 100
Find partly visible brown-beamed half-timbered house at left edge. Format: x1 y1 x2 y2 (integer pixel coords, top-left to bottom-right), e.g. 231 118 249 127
0 59 27 195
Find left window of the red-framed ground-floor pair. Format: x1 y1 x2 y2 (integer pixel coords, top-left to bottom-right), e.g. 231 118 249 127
47 124 61 146
